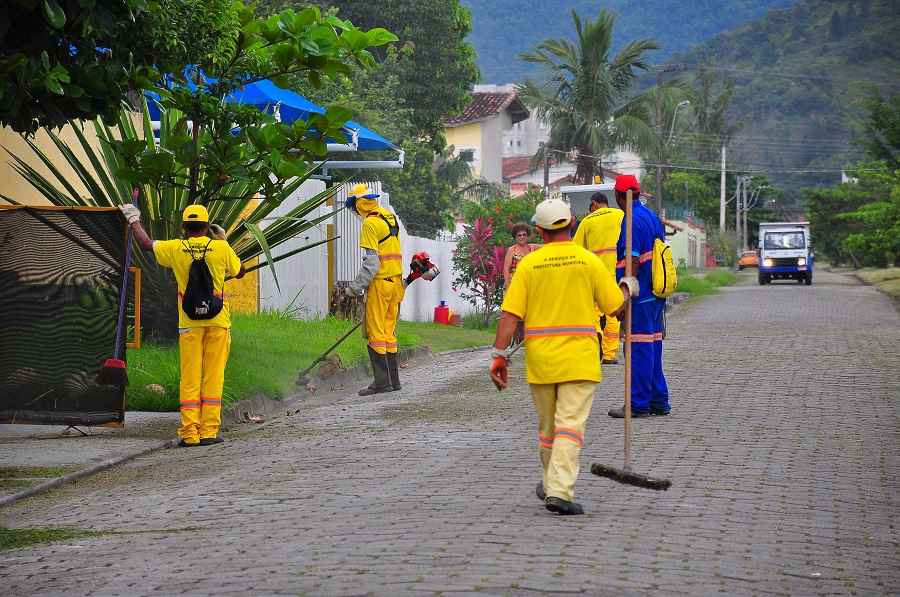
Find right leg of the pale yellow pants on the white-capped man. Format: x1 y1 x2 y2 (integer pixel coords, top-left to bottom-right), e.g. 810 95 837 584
544 381 597 502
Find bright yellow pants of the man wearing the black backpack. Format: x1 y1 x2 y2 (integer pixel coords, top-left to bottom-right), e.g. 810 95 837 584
178 327 231 444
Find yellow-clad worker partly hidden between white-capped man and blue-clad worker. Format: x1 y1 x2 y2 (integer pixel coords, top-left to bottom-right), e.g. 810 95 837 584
573 192 625 365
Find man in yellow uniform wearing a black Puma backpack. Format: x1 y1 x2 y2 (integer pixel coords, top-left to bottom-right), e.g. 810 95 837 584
119 203 244 448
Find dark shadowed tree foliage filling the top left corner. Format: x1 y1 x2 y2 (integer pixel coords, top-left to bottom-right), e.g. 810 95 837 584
0 0 157 134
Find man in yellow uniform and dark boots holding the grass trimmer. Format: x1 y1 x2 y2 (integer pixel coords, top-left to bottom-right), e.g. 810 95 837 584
345 183 404 396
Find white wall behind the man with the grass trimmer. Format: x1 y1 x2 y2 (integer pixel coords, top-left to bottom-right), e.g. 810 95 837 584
259 180 474 321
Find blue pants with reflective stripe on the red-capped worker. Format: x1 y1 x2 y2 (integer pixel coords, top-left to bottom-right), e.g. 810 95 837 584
631 298 669 413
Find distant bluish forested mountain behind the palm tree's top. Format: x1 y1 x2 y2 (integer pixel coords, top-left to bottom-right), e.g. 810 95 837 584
461 0 796 83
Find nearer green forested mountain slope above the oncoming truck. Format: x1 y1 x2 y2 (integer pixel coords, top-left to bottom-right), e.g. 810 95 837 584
671 0 900 187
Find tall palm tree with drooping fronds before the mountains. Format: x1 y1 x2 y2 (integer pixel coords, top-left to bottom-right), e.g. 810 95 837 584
519 10 659 184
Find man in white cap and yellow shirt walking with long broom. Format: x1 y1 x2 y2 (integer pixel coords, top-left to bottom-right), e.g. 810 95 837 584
491 199 637 515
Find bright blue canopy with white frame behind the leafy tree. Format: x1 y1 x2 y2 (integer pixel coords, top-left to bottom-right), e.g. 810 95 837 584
147 77 404 169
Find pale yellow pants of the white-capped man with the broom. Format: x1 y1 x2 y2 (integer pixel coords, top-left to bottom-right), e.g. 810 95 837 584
531 381 597 502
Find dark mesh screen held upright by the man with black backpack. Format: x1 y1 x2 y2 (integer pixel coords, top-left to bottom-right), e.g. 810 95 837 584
0 206 131 425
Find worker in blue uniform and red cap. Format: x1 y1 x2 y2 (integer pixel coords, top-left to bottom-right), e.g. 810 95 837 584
609 174 670 418
